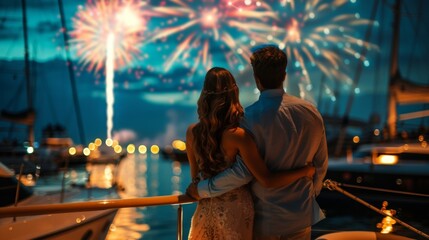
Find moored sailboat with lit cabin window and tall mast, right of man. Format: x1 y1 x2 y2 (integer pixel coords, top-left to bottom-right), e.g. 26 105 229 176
320 0 429 194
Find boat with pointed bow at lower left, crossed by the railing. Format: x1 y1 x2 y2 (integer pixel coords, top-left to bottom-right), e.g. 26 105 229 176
0 159 118 240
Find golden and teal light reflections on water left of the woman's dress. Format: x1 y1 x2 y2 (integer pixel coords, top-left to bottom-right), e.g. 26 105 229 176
106 153 193 240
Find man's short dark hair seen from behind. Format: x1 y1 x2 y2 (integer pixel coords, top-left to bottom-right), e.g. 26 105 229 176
250 45 287 89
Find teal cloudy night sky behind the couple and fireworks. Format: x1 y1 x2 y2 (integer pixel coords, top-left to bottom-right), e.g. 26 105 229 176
0 0 429 146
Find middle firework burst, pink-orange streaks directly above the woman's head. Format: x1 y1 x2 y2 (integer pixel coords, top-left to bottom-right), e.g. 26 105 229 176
145 0 276 73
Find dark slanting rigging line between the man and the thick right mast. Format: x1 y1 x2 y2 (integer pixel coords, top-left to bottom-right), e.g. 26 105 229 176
335 0 379 156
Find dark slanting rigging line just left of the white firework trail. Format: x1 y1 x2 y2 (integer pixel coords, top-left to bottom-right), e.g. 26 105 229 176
58 0 85 145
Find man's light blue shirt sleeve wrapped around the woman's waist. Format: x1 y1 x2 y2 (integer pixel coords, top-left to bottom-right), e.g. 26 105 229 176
198 157 253 198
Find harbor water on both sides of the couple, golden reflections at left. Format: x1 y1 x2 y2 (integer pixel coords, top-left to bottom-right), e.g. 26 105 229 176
87 155 429 240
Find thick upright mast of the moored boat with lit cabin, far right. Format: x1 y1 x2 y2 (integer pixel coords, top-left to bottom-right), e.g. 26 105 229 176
387 0 401 140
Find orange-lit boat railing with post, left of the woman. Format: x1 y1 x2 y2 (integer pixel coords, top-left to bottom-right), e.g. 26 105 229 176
0 195 196 240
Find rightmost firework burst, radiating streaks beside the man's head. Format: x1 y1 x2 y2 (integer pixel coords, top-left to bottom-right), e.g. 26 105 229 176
268 0 377 99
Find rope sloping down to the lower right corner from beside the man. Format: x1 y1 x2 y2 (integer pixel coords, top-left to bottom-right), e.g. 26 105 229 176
323 179 429 239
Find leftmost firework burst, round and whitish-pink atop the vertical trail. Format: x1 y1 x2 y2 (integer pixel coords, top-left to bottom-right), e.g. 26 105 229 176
70 0 151 71
